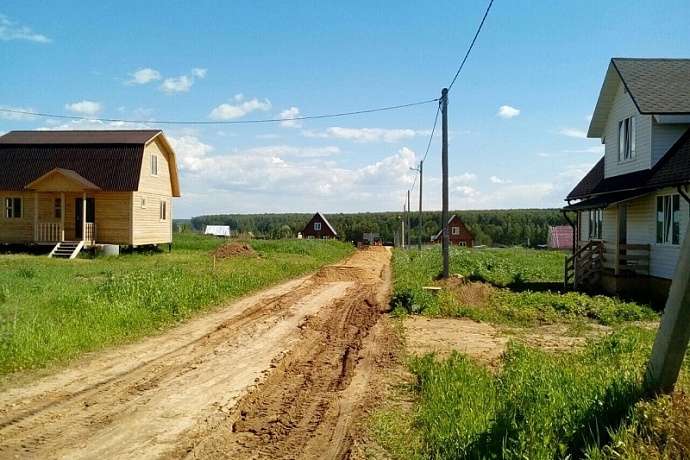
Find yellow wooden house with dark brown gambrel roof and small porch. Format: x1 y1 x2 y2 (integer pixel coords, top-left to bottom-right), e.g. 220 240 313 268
0 130 180 255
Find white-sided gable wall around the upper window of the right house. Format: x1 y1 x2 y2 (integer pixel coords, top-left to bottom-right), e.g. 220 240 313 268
604 83 652 178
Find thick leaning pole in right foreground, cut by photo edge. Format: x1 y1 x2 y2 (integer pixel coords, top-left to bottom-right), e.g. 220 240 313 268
645 225 690 393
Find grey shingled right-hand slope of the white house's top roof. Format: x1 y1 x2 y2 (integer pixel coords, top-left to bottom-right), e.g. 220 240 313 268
611 58 690 114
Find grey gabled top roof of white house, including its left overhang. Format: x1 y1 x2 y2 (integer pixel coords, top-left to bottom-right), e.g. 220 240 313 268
587 58 690 138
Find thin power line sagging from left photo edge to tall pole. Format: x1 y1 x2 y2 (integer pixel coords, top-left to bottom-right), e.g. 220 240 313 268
0 98 438 125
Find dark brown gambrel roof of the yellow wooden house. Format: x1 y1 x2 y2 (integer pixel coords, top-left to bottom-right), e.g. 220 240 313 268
0 130 160 191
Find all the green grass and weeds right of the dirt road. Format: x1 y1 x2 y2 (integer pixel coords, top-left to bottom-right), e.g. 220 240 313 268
370 248 690 460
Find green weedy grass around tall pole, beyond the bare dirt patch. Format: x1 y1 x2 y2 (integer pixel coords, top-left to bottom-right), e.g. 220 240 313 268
391 247 658 325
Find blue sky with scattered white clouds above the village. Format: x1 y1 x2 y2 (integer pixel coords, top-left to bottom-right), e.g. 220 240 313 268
0 0 690 218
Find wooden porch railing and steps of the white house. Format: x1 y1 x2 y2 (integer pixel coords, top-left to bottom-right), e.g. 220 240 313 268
563 240 650 290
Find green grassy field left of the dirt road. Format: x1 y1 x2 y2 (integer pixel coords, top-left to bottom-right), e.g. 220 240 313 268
0 234 353 376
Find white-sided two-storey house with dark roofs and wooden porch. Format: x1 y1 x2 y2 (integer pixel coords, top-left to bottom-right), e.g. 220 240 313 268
564 58 690 304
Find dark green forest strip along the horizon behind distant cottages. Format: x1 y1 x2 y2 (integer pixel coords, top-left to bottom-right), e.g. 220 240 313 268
184 209 575 247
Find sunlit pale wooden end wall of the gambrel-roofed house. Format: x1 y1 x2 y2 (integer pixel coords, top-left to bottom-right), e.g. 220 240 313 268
128 139 173 246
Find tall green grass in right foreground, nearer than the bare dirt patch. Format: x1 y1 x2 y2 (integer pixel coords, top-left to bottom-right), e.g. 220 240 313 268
411 329 652 460
